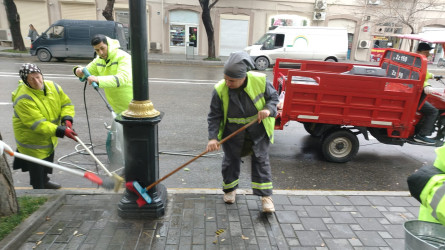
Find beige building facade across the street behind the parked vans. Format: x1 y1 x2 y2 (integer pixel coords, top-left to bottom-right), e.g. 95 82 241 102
0 0 445 61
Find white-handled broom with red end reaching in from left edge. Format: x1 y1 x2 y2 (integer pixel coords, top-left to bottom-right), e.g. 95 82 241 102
0 140 119 190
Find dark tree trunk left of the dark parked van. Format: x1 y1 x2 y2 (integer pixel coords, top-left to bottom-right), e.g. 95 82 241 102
3 0 26 51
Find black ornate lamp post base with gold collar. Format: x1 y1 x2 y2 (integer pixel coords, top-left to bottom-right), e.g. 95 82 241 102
116 100 167 218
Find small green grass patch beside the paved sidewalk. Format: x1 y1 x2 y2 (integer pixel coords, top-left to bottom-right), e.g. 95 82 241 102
0 196 48 240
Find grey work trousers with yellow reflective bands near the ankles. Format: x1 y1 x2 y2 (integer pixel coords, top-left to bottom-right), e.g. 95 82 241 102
221 134 272 196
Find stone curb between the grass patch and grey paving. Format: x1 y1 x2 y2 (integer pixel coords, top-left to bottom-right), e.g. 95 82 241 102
0 194 66 250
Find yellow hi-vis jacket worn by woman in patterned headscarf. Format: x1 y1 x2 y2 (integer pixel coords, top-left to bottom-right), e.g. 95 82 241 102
12 81 75 159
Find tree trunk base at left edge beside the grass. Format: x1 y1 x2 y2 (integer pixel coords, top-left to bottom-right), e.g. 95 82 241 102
0 133 19 217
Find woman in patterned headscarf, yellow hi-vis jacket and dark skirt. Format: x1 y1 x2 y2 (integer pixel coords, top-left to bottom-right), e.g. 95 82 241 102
12 63 77 189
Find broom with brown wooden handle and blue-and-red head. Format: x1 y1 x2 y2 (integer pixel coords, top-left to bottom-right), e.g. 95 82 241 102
125 119 258 207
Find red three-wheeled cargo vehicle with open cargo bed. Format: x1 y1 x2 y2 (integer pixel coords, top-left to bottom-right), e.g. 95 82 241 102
273 49 445 162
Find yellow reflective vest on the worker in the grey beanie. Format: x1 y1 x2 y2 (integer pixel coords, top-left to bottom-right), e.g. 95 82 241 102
215 71 275 143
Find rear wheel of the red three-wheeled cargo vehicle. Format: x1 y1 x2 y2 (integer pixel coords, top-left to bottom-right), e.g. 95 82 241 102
321 129 359 163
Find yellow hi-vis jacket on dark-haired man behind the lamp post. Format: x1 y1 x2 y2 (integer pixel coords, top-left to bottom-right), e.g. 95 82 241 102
86 37 133 114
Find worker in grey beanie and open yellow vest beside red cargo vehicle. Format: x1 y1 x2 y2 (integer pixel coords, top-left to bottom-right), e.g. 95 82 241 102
206 51 278 213
